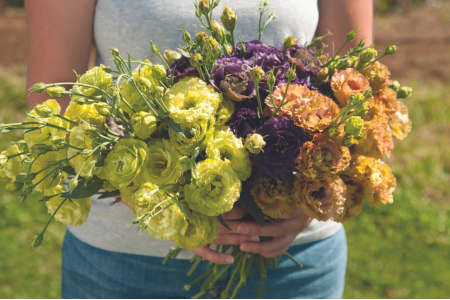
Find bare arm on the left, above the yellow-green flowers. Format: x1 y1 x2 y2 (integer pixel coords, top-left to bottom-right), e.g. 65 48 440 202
25 0 95 111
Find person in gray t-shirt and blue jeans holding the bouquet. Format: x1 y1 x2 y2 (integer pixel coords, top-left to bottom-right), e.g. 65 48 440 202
25 0 373 298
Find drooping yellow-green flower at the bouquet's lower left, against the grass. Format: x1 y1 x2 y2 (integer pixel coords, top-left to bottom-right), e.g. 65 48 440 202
44 185 92 226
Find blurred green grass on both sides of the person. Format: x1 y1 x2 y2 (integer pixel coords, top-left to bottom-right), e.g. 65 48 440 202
0 70 450 298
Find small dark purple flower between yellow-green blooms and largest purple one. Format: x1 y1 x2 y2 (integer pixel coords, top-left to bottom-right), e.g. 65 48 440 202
228 107 264 138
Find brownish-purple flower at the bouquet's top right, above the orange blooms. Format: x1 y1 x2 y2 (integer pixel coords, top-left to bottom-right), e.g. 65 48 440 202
286 45 322 76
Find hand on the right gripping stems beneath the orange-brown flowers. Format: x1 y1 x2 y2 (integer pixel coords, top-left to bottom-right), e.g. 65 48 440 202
219 206 312 258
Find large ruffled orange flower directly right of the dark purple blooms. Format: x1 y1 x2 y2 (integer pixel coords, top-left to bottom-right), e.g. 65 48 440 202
264 83 340 134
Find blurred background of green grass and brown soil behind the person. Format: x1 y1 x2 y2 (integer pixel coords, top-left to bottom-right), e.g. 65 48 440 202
0 0 450 298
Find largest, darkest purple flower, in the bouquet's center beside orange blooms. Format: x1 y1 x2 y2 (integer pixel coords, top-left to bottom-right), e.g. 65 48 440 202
250 117 307 179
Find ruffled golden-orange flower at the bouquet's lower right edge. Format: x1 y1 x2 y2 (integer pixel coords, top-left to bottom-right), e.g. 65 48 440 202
342 154 396 208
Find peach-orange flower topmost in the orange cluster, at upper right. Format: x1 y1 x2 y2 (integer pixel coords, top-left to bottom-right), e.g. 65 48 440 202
331 68 370 107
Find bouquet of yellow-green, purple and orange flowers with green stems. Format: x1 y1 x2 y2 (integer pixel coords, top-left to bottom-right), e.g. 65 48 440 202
0 0 411 298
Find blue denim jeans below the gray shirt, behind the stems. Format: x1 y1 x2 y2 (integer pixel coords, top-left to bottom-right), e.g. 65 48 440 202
62 228 347 299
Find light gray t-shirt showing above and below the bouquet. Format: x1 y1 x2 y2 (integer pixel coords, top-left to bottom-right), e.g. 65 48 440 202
68 0 341 259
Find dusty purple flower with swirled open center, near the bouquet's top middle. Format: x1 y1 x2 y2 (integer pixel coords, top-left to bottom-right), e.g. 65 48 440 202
210 62 256 102
